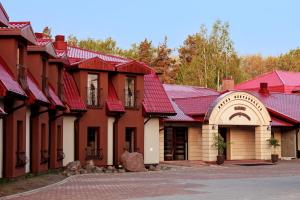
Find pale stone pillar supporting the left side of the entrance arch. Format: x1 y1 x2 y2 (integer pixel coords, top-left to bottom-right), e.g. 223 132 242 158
202 124 218 161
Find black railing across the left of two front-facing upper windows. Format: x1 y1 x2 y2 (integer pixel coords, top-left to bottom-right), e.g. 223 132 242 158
86 87 103 108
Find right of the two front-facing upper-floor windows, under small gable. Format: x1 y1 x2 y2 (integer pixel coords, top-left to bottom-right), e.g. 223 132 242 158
125 76 136 108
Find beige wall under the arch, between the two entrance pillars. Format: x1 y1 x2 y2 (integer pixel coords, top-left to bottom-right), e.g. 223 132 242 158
228 127 255 160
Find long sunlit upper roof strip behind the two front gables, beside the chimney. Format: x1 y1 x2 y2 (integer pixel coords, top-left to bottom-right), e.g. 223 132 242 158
67 46 129 63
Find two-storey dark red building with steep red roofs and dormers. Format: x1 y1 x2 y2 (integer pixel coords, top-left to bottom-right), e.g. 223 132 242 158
0 5 175 178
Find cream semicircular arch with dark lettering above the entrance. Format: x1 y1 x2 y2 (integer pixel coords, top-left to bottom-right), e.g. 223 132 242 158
205 92 271 126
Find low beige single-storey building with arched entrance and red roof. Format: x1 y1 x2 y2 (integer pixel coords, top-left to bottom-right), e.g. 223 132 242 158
160 79 300 161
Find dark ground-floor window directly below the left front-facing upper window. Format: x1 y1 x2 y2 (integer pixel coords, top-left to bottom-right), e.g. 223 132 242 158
86 127 103 160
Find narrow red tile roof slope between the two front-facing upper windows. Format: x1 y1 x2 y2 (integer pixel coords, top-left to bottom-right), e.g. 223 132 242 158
106 80 125 112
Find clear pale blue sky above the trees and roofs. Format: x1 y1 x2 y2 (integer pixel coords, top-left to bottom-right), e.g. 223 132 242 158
1 0 300 56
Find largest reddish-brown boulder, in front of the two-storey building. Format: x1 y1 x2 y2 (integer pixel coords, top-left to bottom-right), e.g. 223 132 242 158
121 151 147 172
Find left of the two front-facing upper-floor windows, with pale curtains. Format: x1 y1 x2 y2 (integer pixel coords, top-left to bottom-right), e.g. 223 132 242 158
87 74 99 106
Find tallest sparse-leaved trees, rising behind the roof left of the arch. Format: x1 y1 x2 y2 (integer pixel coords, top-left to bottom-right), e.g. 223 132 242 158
177 20 242 89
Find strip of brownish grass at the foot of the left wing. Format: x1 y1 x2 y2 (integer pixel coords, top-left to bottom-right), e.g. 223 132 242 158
0 170 66 197
